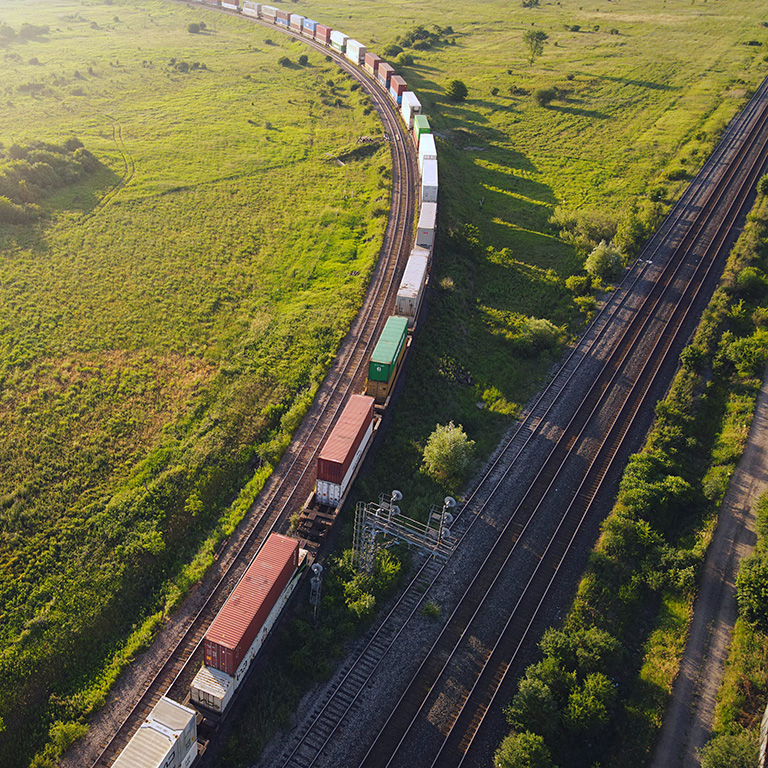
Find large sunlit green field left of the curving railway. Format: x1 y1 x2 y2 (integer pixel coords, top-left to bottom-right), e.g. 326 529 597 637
0 1 389 768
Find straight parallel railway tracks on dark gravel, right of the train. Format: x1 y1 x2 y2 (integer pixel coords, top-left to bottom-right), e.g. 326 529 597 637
272 73 768 768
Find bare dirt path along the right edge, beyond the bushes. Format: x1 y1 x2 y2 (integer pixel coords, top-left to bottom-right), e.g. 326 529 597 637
651 368 768 768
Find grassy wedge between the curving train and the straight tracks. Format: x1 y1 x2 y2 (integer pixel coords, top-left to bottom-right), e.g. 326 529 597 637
214 1 768 765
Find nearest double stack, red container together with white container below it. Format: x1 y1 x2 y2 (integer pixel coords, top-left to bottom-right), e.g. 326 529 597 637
190 533 307 714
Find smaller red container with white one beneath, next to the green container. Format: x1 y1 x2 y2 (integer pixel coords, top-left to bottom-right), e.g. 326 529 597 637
315 395 374 507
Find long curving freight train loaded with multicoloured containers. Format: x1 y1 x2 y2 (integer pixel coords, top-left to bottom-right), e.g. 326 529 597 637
113 0 438 768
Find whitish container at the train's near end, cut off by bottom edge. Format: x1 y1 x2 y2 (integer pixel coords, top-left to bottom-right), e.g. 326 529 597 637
112 696 197 768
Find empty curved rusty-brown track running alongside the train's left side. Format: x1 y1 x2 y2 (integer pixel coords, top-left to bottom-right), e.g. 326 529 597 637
85 11 416 768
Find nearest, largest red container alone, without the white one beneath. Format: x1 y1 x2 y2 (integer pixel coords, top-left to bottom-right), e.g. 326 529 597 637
203 533 299 677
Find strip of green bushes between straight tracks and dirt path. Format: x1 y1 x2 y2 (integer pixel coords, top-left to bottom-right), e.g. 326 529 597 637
499 197 768 766
